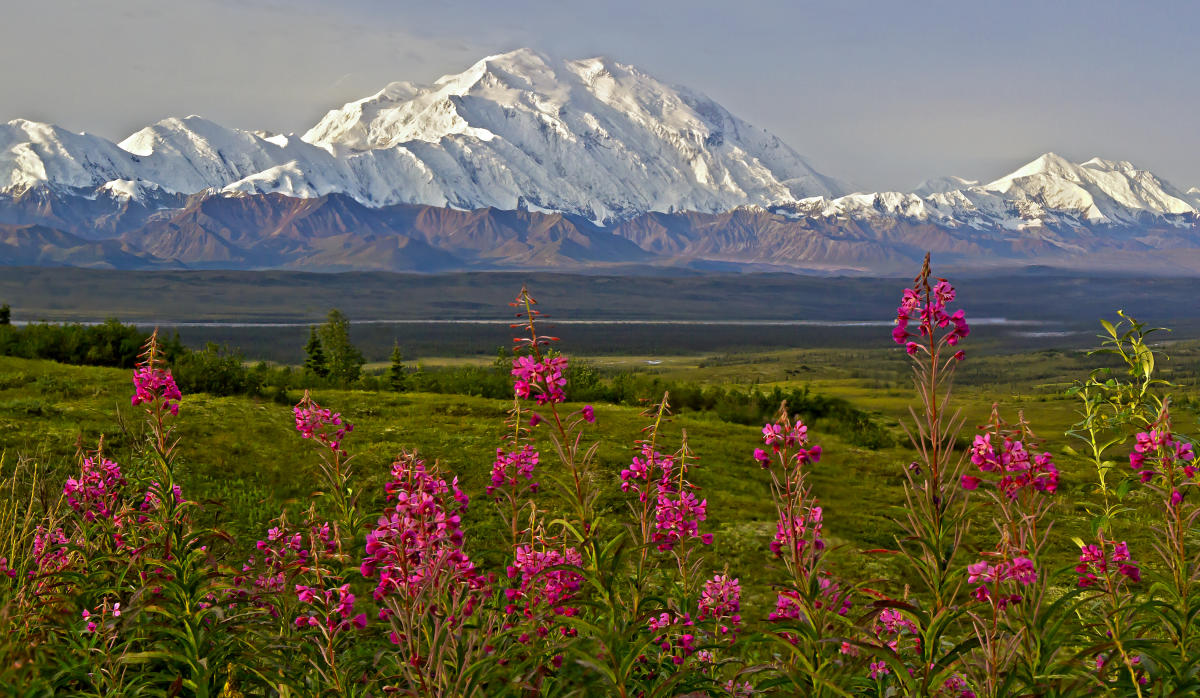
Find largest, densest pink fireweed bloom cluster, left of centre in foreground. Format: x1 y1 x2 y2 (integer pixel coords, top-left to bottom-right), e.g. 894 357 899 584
361 453 488 615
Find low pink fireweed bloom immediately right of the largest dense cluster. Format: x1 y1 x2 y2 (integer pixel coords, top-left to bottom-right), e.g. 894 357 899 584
504 546 583 634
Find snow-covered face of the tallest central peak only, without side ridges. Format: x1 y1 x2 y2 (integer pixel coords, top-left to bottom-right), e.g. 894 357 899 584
304 49 841 221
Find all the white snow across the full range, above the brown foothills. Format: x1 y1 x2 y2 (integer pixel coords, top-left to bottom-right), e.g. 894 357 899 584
0 49 1200 237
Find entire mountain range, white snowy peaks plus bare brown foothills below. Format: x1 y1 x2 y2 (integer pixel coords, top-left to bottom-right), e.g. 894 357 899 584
0 49 1200 273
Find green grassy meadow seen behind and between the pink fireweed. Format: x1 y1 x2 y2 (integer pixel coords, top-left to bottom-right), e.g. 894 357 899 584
0 335 1200 616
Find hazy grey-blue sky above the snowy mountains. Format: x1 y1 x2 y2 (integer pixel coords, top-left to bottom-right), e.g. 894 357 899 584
0 0 1200 189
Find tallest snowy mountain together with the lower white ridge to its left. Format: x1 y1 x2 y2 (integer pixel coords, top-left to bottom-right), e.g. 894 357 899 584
0 49 842 222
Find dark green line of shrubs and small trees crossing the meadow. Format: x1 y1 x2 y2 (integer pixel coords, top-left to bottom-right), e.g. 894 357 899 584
0 306 895 449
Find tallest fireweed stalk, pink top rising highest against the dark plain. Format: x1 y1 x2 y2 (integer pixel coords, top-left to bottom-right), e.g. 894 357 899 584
892 254 971 693
